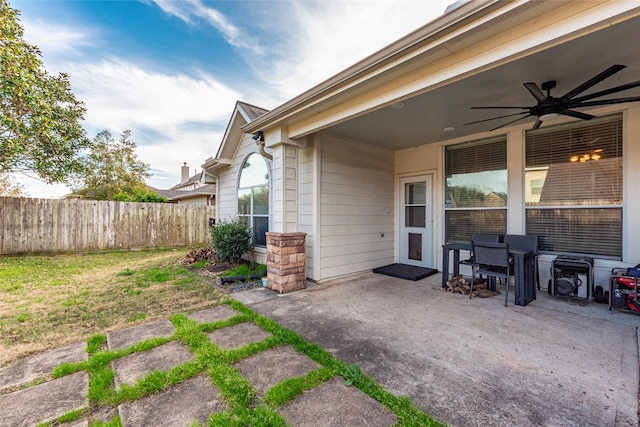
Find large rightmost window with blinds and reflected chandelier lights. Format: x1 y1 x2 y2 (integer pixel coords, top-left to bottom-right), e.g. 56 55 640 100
523 114 624 261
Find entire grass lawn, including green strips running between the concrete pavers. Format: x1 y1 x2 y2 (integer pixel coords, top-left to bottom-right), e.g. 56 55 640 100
0 250 442 427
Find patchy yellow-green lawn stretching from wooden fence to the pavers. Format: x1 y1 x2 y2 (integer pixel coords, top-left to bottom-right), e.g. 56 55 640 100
0 250 224 367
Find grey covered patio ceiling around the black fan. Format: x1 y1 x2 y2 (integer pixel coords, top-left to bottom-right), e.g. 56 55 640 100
328 13 640 149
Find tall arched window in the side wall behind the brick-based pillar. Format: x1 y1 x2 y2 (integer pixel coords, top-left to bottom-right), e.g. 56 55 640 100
238 153 269 246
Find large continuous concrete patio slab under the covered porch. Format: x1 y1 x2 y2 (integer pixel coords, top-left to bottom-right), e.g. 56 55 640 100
232 273 640 426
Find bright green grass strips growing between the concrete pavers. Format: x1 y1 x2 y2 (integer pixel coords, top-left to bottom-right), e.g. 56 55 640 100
47 301 442 427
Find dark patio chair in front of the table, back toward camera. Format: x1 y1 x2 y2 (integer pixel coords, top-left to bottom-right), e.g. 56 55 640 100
469 242 511 307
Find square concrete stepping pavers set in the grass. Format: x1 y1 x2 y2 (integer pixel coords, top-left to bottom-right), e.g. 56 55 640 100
0 306 396 427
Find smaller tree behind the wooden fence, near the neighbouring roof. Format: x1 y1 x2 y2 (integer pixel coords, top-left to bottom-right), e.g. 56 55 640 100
74 130 151 200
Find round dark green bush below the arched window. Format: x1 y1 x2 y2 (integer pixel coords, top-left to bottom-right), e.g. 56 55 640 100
211 218 252 265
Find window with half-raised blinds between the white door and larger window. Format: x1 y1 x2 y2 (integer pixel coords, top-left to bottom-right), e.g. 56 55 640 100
445 137 507 242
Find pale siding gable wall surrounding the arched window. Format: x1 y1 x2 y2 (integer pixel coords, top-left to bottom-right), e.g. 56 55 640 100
216 135 271 263
